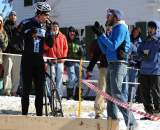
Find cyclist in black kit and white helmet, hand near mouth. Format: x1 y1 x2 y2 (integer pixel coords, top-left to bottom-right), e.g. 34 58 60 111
18 2 53 116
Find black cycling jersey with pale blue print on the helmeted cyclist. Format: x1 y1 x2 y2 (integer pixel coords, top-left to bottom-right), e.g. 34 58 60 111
18 17 53 56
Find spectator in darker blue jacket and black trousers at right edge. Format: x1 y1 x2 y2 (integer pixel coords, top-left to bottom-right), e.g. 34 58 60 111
138 21 160 119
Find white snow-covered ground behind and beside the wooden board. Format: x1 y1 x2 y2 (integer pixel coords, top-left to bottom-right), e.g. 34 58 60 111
0 96 160 130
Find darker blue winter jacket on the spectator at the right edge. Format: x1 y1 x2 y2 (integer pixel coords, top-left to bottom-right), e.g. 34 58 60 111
138 37 160 75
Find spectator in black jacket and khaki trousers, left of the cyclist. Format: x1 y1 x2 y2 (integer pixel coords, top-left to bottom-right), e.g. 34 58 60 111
3 11 22 95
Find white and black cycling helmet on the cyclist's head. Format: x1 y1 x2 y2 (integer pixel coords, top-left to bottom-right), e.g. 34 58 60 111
34 2 51 15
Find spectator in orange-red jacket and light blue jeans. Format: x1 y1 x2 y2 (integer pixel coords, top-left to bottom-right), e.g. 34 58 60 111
44 22 68 97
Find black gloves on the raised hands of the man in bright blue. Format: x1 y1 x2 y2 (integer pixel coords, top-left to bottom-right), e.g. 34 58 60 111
92 21 105 36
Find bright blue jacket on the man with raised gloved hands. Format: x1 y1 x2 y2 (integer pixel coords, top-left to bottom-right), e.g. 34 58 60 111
98 23 131 62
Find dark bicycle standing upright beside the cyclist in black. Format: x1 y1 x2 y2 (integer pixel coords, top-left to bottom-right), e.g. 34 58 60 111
44 61 63 117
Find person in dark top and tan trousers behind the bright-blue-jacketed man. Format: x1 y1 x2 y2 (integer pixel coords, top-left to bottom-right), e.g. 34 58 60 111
86 24 112 119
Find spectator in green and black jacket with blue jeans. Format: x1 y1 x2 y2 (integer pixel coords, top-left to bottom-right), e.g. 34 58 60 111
65 26 82 99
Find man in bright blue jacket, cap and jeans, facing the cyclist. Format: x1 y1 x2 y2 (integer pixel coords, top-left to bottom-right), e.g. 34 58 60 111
93 9 136 130
